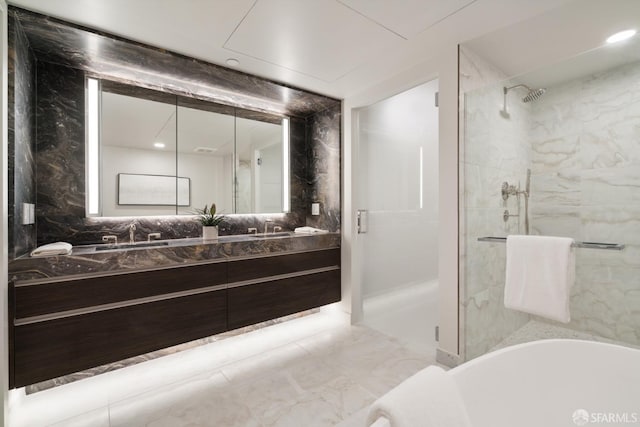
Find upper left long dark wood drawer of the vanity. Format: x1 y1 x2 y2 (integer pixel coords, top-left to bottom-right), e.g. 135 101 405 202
14 262 227 319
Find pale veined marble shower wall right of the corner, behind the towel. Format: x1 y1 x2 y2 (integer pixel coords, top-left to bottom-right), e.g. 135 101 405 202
530 62 640 345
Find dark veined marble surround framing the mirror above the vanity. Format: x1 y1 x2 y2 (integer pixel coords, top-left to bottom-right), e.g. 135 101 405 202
11 7 341 249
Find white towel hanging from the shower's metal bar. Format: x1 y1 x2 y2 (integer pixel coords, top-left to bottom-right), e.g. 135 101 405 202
504 236 575 323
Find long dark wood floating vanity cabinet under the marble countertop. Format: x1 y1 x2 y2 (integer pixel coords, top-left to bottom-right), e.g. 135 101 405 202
10 248 341 387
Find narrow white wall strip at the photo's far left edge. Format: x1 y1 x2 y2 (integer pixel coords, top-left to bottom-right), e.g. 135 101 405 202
0 0 9 426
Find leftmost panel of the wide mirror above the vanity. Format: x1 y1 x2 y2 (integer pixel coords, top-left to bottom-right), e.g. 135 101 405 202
95 82 177 216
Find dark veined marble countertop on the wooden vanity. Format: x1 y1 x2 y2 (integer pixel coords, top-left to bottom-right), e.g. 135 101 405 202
9 233 340 281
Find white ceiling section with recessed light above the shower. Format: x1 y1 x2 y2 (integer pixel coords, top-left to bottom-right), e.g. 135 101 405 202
465 0 640 87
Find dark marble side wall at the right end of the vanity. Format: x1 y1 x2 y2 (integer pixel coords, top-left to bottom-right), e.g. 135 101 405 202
306 105 342 231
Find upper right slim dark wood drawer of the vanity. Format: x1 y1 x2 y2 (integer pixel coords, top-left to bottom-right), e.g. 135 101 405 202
229 248 340 283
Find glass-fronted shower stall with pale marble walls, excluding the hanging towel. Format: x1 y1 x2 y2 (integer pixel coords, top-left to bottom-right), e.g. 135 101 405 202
459 42 640 360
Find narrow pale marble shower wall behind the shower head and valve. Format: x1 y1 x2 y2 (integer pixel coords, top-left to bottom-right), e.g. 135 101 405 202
459 47 530 360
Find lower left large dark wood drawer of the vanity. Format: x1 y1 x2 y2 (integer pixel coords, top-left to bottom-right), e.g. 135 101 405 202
13 290 227 387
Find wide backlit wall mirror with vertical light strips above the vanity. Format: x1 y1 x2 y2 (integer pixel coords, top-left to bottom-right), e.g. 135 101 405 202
86 79 289 217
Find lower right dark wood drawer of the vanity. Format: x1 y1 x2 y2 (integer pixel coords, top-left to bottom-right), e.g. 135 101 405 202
228 268 341 329
